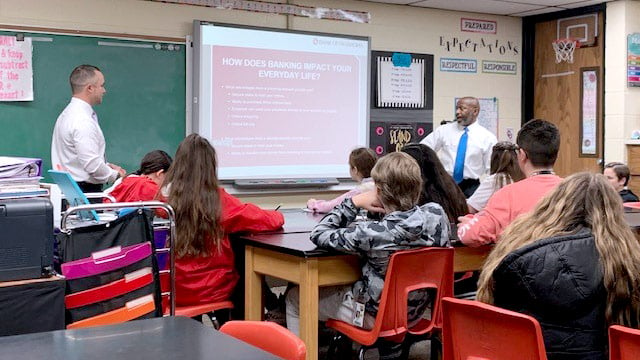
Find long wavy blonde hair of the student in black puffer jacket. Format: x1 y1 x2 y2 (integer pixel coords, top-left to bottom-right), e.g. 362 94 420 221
478 172 640 328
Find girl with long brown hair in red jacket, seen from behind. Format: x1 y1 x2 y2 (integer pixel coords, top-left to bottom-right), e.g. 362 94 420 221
161 134 284 306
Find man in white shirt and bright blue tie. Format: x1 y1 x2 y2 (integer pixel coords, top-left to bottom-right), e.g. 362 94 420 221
421 97 498 198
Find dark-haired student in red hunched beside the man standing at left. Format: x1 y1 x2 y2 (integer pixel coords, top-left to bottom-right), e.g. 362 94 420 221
105 150 171 202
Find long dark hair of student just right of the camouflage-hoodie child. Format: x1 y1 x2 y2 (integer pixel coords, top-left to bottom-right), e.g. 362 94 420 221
402 144 467 221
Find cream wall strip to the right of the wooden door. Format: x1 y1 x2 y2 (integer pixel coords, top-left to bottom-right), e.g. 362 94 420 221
604 1 640 162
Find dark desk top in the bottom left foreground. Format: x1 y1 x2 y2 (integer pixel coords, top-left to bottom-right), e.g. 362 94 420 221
0 317 278 360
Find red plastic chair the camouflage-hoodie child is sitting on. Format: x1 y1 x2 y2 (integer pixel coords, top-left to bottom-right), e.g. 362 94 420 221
327 247 453 359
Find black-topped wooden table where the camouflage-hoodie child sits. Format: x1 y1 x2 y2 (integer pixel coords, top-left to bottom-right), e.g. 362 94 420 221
238 210 490 359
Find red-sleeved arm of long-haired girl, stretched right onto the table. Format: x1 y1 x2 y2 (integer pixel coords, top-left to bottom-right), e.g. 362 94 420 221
218 188 284 233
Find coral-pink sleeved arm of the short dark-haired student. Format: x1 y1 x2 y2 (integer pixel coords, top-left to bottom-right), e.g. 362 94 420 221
458 189 511 247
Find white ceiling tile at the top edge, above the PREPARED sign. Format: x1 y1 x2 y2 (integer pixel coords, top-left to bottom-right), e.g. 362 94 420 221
411 0 542 15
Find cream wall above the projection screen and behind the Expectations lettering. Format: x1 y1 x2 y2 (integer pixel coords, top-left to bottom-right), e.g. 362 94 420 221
0 0 522 205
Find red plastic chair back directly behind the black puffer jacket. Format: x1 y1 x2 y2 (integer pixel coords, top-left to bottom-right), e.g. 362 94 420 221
442 298 547 360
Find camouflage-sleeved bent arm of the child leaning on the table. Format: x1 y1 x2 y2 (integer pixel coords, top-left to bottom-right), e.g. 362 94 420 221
311 191 382 254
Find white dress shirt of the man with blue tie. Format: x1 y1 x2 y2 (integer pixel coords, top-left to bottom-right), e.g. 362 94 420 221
420 121 498 179
